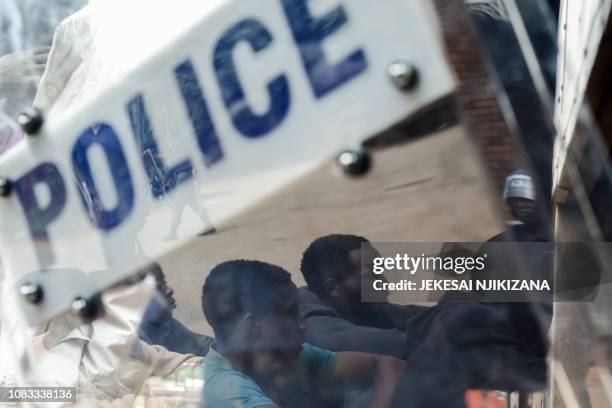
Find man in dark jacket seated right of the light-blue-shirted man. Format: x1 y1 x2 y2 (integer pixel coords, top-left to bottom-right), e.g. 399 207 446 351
299 235 546 407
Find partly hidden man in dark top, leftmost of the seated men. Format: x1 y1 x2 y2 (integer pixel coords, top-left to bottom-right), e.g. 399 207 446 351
138 262 215 357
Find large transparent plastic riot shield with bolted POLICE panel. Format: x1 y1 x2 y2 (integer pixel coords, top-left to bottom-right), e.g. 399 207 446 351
0 0 606 407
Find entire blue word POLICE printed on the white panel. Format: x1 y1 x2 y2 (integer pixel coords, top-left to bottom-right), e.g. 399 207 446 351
14 0 368 257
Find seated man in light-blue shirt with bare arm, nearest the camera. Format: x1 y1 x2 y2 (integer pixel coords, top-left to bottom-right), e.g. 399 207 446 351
202 260 404 408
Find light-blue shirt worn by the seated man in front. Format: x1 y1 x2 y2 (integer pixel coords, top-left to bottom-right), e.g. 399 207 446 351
203 343 336 408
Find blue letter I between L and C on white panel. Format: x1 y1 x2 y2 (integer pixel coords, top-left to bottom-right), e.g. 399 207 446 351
174 60 223 167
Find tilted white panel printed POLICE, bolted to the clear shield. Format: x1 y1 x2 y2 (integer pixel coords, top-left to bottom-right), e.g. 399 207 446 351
0 0 455 324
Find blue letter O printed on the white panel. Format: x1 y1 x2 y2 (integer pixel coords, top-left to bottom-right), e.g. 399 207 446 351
72 123 134 231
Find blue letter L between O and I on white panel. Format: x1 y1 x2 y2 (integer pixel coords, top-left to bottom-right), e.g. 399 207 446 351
127 94 193 198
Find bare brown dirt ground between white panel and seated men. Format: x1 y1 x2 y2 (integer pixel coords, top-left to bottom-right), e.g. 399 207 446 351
160 127 503 334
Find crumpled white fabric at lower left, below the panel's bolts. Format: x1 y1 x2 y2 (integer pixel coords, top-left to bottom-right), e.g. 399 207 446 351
0 278 199 407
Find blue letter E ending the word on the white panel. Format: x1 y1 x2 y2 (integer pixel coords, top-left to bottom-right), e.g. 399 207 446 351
281 0 367 98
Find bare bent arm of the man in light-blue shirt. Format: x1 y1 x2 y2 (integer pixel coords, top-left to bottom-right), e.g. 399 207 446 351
332 351 406 408
